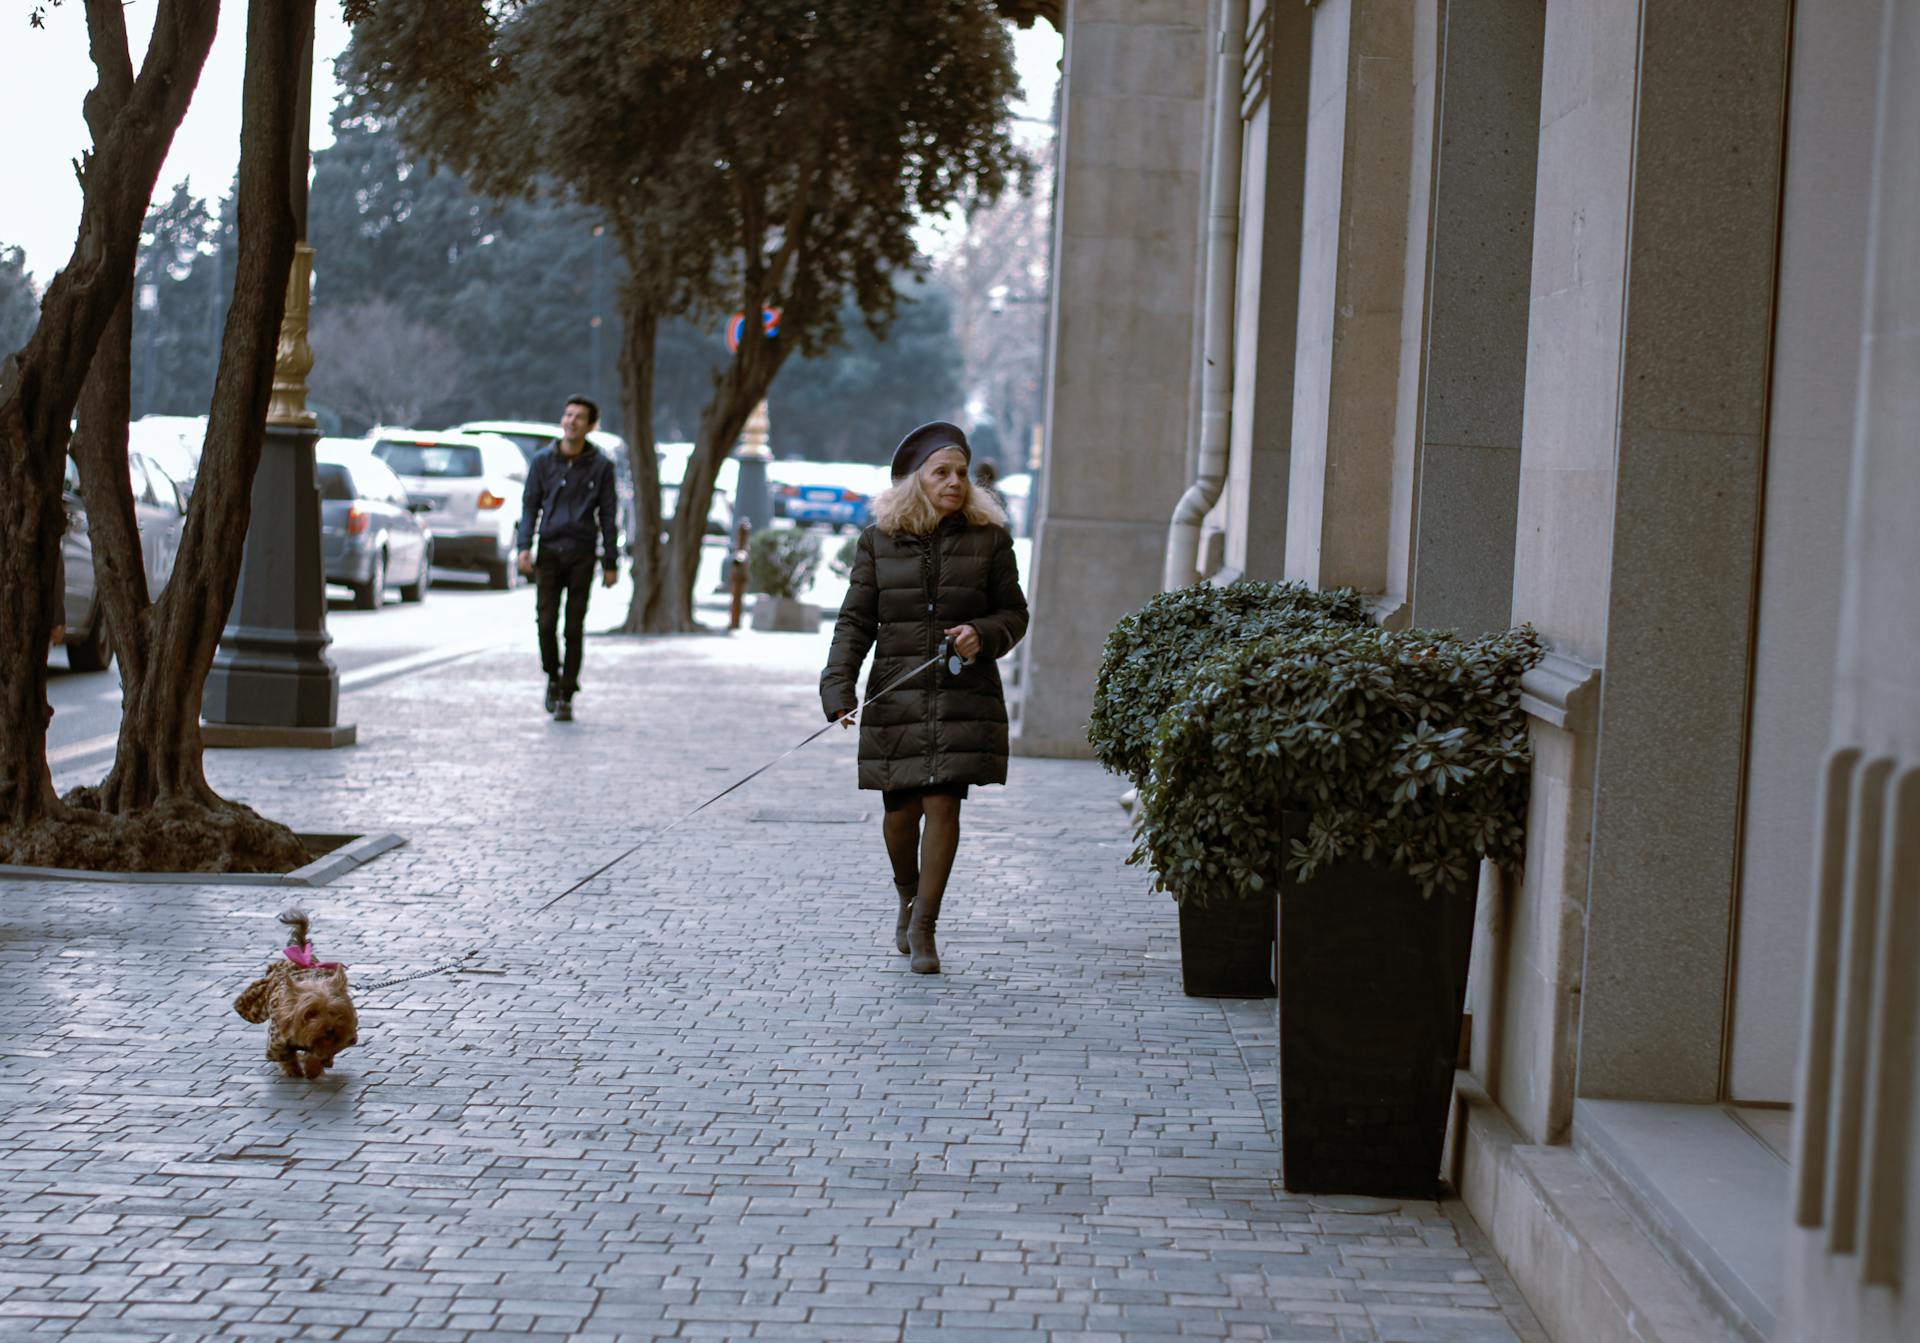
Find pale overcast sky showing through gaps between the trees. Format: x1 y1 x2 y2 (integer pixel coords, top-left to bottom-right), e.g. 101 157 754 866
0 0 1060 284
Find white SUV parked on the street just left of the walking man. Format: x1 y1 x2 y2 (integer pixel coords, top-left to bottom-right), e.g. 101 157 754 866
369 428 526 588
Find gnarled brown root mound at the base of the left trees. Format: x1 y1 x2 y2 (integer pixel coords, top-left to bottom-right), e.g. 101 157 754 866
0 788 313 872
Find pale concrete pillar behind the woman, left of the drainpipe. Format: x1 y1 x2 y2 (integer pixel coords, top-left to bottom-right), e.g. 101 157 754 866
1014 0 1212 755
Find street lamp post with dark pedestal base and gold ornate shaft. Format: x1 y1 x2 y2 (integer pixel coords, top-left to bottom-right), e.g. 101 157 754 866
200 5 357 747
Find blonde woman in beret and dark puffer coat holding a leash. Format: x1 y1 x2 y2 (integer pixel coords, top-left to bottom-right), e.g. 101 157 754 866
820 421 1027 974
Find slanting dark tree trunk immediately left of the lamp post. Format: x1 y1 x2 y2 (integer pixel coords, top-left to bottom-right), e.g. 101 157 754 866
100 0 313 818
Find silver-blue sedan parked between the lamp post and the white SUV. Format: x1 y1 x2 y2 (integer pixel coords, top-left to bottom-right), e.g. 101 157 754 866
313 438 434 611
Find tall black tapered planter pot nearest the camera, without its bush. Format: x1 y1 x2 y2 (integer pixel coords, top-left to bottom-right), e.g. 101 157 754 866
1279 815 1476 1199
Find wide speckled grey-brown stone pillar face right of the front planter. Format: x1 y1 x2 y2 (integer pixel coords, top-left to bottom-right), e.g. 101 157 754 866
1578 0 1789 1101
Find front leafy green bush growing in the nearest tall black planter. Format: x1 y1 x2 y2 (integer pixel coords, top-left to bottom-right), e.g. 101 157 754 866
1129 621 1540 903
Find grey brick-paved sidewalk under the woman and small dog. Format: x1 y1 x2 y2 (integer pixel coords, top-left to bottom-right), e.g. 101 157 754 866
0 632 1544 1343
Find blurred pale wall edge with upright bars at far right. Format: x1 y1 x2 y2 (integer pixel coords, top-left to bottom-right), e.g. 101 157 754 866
1782 4 1920 1343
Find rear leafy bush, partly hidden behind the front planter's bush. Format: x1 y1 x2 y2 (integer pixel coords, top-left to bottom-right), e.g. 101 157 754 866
1087 582 1371 784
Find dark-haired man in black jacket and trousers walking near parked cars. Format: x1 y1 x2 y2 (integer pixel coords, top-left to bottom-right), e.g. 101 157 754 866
515 396 620 722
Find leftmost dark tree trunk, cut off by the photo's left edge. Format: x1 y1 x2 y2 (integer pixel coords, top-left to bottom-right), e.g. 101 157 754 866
0 0 219 833
